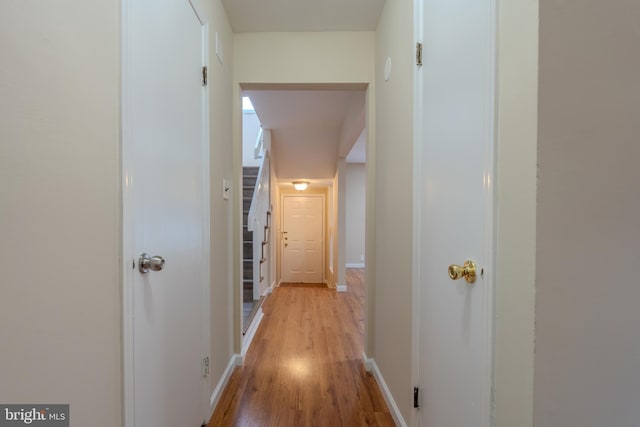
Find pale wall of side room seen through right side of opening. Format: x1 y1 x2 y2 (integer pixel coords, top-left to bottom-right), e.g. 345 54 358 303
345 163 367 266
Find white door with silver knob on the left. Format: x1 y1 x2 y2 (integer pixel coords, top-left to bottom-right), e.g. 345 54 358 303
123 0 208 427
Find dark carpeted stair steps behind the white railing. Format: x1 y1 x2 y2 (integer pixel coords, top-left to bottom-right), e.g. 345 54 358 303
242 167 258 302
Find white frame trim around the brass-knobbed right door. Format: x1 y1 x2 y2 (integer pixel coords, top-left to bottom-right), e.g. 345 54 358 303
410 0 499 427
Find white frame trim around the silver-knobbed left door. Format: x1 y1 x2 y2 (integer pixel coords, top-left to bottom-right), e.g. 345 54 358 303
120 0 211 427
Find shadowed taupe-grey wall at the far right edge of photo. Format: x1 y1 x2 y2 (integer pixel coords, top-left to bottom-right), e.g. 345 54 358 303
535 0 640 427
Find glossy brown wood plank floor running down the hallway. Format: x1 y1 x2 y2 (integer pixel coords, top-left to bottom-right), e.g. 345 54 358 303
208 269 395 427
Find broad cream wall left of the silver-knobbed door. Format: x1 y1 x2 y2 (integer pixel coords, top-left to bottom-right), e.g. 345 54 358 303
0 0 122 426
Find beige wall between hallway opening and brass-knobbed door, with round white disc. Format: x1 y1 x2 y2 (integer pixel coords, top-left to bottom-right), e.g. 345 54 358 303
367 0 415 420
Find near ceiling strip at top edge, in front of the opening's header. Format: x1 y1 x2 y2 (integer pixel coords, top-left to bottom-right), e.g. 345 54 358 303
222 0 384 33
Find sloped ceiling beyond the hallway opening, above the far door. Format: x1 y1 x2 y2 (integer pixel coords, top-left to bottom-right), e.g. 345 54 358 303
243 89 365 181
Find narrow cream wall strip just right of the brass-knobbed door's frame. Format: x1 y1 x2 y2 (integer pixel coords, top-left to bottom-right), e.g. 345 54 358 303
494 0 538 427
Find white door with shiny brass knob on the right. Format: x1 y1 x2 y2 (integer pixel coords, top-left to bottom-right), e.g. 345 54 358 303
416 0 495 427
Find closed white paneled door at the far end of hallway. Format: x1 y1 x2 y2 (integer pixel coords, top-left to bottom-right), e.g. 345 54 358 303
282 195 324 283
